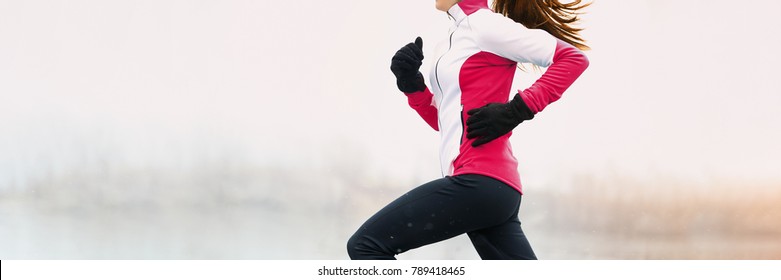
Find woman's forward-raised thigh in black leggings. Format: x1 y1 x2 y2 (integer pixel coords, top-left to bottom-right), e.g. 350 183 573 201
350 175 520 257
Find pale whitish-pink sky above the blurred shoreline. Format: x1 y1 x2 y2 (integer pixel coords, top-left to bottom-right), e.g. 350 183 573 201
0 0 781 189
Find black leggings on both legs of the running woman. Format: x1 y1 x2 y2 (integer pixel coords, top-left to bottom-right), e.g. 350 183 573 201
347 174 537 260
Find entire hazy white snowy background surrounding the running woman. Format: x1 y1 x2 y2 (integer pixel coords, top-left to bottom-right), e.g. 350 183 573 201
0 0 781 259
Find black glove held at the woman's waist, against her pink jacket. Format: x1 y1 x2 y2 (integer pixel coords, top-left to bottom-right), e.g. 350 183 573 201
466 94 534 147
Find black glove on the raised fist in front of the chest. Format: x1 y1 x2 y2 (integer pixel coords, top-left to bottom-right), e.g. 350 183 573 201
391 37 426 93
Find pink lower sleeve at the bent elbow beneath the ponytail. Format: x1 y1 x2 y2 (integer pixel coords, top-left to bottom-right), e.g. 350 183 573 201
518 40 589 114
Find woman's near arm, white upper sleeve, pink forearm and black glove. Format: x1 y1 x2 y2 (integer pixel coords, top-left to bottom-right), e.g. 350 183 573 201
466 11 589 147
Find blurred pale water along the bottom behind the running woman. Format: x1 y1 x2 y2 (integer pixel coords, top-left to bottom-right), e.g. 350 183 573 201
0 175 781 259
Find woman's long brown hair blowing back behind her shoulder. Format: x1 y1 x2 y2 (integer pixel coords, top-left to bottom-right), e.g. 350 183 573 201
493 0 591 50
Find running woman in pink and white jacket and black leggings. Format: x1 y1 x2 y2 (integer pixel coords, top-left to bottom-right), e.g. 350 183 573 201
347 0 589 259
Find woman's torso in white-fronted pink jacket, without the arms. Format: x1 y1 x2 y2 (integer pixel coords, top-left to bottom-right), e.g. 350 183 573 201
428 5 521 194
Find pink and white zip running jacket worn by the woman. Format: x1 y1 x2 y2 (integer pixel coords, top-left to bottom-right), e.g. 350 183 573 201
407 0 589 192
